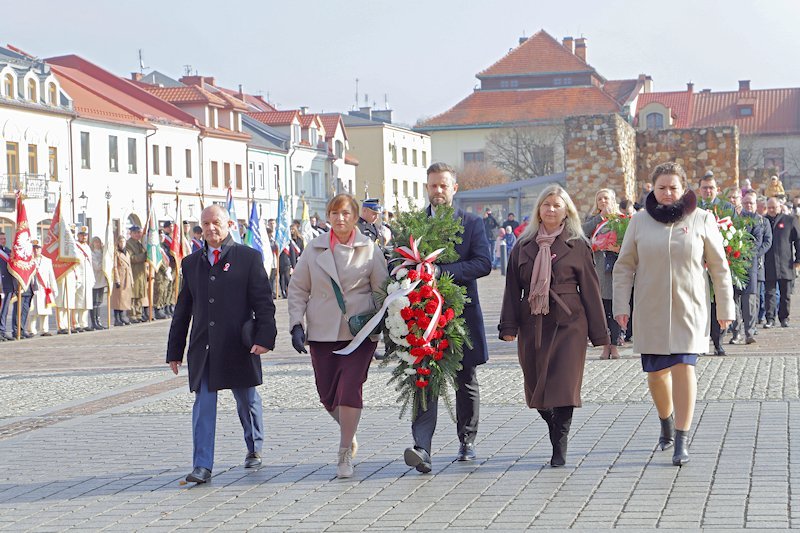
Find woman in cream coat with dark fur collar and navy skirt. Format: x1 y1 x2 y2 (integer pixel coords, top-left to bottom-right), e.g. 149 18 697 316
613 163 735 466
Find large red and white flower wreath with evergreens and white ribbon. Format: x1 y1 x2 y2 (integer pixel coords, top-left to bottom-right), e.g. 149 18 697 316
377 206 472 420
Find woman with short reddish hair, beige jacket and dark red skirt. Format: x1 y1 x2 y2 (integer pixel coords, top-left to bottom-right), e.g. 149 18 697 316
288 194 389 478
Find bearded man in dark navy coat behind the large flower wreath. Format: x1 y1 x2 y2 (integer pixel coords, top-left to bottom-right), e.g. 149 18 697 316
404 163 492 473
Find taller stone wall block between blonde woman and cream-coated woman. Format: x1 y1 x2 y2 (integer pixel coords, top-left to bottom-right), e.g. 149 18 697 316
564 114 636 216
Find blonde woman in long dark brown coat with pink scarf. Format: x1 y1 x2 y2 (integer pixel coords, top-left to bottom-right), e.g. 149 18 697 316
499 185 611 466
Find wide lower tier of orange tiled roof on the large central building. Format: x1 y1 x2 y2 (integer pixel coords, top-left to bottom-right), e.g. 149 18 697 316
419 86 620 130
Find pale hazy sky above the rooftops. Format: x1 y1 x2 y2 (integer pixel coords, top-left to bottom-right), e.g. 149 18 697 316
6 0 800 124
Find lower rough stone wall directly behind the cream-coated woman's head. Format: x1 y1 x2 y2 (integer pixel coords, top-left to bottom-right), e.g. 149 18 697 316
636 126 739 190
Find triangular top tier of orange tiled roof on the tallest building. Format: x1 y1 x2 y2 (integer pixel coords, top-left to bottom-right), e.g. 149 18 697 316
478 30 594 78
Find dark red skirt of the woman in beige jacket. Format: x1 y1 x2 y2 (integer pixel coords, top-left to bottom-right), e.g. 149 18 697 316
308 339 378 411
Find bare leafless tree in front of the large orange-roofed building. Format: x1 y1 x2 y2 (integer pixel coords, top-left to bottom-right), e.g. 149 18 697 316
486 127 564 181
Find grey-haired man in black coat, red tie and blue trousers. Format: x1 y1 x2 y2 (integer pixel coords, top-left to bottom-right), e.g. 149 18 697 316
167 205 277 483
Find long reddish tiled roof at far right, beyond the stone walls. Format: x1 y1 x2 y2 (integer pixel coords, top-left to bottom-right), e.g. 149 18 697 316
637 88 800 135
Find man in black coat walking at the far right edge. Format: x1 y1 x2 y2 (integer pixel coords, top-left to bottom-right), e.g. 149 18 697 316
764 197 800 328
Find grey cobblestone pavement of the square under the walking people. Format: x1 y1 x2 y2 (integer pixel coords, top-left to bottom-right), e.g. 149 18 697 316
0 273 800 531
